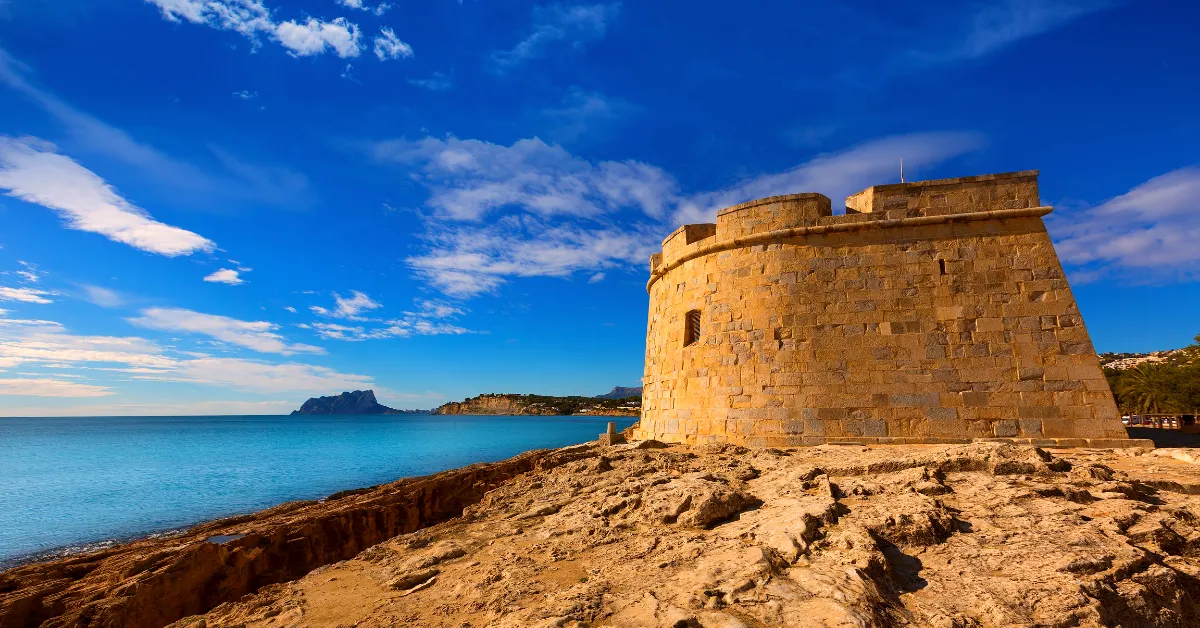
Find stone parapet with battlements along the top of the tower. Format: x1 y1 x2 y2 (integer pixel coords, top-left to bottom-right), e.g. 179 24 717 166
650 171 1051 277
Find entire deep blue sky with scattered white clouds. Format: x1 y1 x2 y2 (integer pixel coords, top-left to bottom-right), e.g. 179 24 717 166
0 0 1200 415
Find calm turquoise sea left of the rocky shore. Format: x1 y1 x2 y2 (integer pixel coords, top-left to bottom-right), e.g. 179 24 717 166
0 414 635 567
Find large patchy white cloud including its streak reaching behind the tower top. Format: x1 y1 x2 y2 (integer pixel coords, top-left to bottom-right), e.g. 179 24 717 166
386 132 983 297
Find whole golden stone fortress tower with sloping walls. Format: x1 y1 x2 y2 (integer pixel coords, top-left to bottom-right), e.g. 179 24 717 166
635 171 1146 447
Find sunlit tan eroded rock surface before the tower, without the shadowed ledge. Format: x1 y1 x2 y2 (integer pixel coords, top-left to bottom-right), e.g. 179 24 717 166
176 443 1200 628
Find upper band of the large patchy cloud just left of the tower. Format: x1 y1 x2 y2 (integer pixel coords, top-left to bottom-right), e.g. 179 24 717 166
373 137 678 220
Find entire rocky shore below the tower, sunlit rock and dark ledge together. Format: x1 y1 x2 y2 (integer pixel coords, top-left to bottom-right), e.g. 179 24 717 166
7 442 1200 628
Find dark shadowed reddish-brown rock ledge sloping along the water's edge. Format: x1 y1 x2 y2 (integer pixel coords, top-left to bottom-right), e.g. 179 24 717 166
0 450 597 628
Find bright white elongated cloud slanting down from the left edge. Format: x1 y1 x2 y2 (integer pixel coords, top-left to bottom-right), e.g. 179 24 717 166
0 136 216 257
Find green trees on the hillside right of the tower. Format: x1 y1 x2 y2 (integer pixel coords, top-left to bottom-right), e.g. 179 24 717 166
1104 334 1200 414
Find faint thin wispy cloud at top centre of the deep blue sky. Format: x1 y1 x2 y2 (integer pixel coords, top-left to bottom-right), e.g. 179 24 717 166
492 2 620 72
